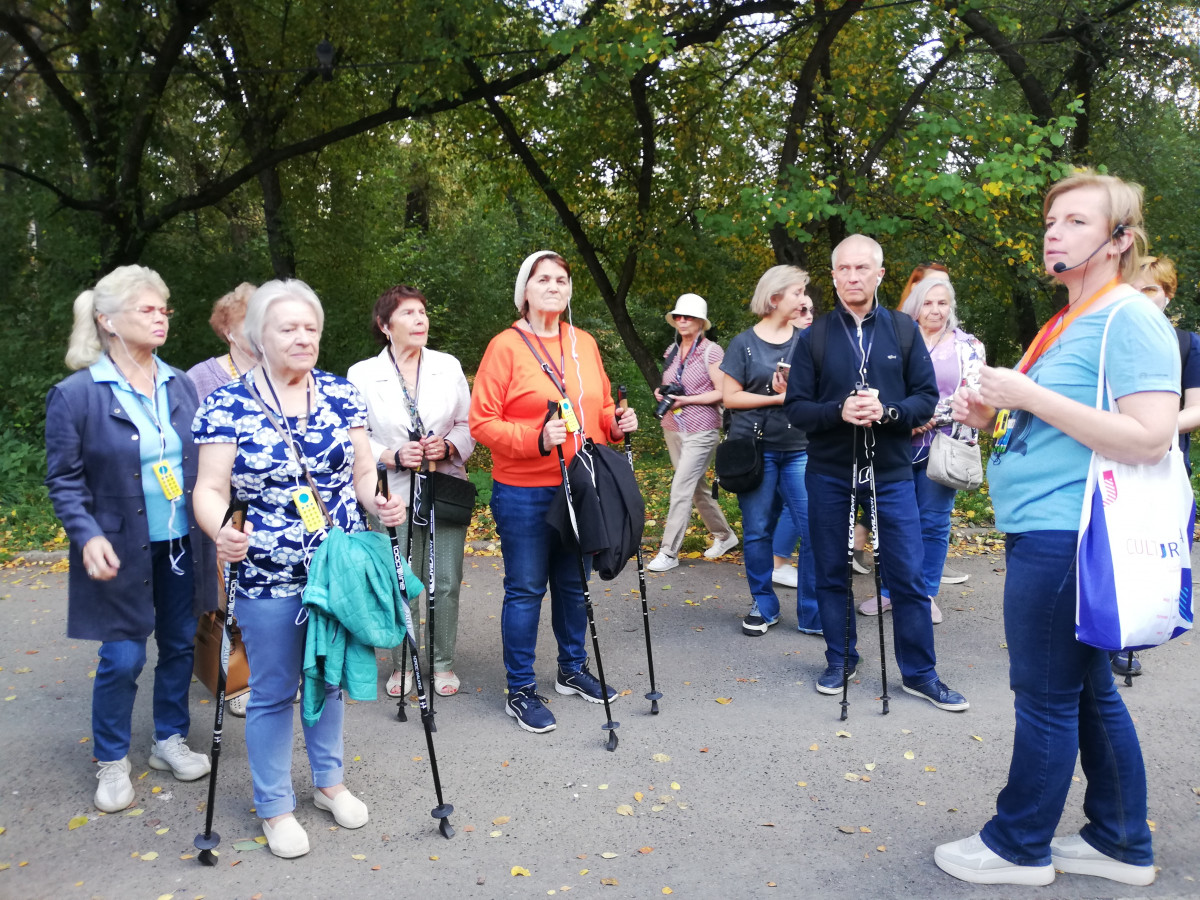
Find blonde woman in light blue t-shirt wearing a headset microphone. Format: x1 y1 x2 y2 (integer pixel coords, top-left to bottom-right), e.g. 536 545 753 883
934 172 1180 884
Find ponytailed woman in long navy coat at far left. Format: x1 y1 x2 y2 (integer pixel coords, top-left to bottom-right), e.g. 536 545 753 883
46 265 216 812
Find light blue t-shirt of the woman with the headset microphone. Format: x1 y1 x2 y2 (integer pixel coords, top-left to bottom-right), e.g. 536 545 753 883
988 298 1180 533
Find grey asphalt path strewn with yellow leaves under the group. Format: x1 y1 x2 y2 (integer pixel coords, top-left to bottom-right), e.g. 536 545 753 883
0 553 1200 900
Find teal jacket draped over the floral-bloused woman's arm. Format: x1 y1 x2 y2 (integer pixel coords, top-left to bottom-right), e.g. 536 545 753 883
304 528 425 726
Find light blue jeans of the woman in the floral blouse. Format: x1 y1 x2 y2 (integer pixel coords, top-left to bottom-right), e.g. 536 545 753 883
234 594 344 818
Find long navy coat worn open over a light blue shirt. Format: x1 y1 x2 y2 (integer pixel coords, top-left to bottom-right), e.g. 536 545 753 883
46 367 217 641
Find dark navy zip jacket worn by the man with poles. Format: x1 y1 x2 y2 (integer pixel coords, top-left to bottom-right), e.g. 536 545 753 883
784 302 937 484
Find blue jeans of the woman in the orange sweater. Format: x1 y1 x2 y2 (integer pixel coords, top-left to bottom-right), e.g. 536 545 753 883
491 481 592 691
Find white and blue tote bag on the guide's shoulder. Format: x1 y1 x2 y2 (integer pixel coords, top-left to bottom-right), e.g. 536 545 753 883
1075 300 1196 650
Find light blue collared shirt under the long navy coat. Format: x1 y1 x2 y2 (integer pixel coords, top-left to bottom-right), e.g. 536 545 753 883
89 355 187 541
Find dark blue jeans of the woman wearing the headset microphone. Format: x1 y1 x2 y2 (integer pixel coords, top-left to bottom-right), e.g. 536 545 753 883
982 532 1154 865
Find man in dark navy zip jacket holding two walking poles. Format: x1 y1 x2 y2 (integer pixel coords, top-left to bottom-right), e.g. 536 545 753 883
784 234 970 712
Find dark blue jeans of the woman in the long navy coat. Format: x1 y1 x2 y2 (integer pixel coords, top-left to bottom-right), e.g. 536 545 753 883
91 539 196 762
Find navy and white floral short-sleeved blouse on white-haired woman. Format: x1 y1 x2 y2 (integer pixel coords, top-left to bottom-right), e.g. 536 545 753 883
192 370 367 596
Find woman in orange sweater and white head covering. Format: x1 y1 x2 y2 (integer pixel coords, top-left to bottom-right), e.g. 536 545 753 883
470 250 637 734
